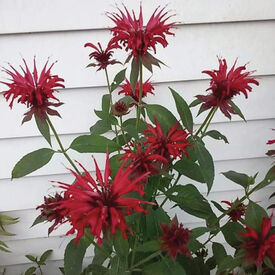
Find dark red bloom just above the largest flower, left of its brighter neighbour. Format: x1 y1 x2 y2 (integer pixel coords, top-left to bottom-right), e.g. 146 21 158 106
121 144 167 177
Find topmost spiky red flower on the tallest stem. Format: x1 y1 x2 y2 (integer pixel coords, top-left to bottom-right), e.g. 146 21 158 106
108 6 175 57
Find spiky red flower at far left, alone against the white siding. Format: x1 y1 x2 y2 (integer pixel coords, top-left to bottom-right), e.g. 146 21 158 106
1 59 65 122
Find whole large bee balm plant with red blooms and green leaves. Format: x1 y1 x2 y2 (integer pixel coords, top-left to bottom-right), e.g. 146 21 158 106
3 4 275 275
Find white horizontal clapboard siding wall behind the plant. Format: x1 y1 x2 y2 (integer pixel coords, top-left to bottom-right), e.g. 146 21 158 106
0 0 275 274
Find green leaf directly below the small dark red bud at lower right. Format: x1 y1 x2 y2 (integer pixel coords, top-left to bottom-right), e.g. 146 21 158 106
221 221 245 248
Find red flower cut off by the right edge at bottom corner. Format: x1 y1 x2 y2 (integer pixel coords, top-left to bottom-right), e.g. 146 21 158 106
239 215 275 265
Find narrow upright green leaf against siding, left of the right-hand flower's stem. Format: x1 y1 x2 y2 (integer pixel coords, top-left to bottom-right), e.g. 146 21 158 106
169 87 193 133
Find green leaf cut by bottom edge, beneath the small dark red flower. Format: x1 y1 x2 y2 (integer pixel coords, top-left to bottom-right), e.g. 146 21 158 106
142 259 186 275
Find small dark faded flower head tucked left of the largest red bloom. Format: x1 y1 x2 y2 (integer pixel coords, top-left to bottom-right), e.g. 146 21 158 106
36 193 66 234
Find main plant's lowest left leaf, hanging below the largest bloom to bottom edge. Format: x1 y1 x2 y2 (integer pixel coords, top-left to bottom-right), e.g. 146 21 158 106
64 236 91 275
